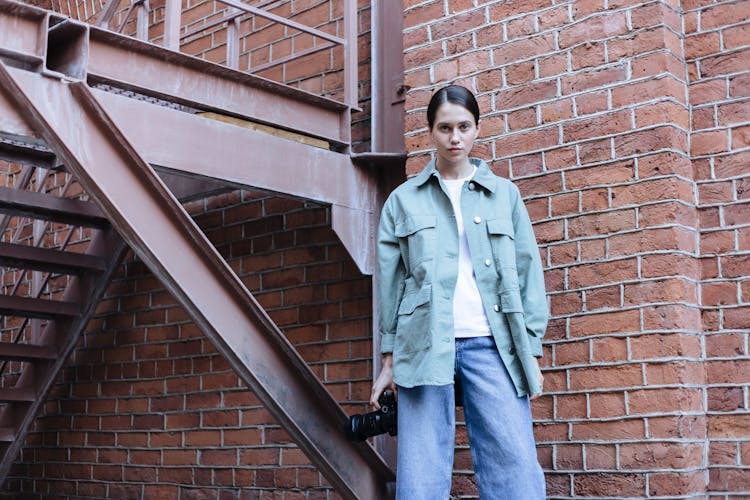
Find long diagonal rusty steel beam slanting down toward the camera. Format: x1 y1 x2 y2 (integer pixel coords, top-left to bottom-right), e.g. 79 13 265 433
0 63 394 499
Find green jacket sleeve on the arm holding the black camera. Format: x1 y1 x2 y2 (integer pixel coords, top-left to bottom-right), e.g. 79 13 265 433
376 202 406 354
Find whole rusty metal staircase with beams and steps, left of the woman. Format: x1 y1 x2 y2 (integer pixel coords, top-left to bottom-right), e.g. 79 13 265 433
0 0 402 499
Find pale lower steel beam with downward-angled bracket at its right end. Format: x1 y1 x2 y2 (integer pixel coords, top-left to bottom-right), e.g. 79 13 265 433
90 85 378 274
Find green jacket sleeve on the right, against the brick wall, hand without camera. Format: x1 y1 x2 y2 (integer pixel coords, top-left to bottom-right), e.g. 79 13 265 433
511 184 549 357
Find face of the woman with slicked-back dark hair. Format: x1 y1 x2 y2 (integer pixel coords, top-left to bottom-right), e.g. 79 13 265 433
430 102 479 172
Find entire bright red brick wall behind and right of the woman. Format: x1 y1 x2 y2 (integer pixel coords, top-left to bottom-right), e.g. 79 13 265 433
404 0 750 498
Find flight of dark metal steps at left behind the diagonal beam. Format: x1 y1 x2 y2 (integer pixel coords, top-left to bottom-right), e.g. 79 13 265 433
0 164 127 484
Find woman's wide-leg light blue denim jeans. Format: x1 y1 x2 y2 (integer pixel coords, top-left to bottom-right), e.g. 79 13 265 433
396 337 545 500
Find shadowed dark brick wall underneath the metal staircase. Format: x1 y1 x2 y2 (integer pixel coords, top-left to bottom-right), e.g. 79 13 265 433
5 191 372 499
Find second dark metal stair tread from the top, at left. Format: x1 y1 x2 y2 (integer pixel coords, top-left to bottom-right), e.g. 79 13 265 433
0 187 108 227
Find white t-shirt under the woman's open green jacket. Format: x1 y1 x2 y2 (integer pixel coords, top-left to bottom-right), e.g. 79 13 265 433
443 167 492 338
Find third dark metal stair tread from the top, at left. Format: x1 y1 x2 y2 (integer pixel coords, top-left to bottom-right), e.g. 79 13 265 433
0 243 106 274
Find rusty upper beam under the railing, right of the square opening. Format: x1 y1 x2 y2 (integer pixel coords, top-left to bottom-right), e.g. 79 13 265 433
88 28 349 143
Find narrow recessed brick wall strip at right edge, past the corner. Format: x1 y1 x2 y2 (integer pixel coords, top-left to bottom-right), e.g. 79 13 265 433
683 1 750 498
